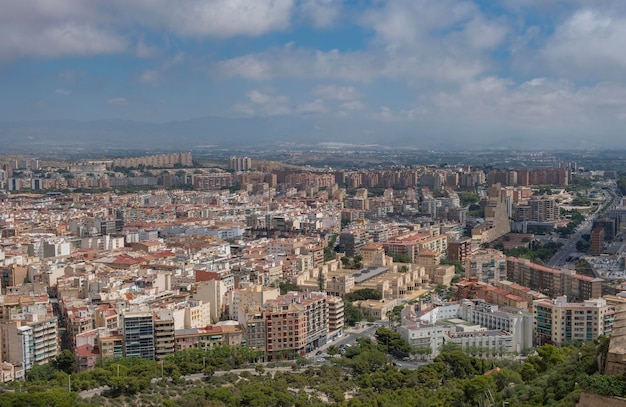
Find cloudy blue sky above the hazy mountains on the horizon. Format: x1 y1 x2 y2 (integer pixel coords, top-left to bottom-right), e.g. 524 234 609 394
0 0 626 148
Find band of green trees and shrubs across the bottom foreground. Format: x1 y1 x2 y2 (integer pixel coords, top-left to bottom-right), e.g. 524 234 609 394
0 342 626 407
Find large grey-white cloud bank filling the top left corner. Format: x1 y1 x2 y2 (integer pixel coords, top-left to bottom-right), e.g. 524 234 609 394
0 0 294 60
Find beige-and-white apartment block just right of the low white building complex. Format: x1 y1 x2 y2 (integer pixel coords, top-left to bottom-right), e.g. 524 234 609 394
533 296 615 345
